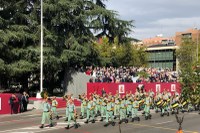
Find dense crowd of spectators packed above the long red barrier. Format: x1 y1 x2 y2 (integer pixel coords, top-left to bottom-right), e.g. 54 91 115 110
85 66 178 83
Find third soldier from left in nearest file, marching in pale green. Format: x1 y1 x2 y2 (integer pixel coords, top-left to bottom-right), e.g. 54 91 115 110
104 98 115 127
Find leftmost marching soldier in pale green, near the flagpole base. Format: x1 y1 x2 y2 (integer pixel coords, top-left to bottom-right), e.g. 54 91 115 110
40 97 53 128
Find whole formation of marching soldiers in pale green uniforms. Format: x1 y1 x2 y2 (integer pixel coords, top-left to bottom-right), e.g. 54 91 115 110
40 90 199 129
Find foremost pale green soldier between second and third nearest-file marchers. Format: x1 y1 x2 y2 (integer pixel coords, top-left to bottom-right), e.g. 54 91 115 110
85 97 95 123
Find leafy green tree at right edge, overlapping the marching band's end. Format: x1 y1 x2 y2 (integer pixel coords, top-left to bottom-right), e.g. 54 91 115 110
177 39 200 103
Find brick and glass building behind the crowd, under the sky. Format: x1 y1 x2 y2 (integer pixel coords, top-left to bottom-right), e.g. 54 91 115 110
141 29 200 70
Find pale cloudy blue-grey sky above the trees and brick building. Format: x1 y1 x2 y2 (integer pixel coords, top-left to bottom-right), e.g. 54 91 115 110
105 0 200 40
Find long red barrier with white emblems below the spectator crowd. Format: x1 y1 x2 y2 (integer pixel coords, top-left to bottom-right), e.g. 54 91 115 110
87 83 181 96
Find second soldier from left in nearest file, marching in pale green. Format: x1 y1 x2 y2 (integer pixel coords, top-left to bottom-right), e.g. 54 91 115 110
65 99 78 129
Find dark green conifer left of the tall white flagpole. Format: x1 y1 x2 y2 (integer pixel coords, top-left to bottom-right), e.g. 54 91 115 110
0 0 40 90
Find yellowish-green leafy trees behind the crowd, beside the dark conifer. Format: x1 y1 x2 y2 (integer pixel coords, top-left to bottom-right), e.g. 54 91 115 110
93 37 147 67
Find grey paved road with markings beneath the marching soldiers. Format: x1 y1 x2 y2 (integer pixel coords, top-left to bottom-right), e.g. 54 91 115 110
0 109 200 133
